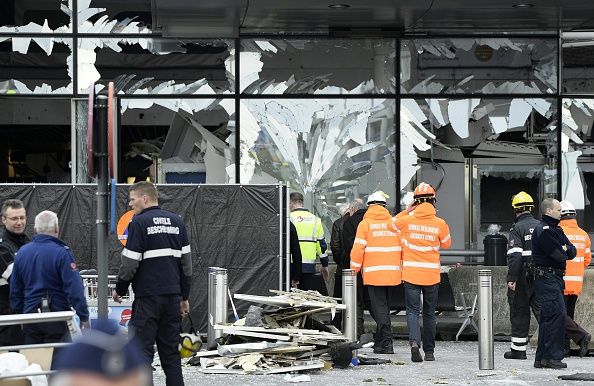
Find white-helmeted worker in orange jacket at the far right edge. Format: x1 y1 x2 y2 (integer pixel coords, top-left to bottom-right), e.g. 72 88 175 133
559 201 592 357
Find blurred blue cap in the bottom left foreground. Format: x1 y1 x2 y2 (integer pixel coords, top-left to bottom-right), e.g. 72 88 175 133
54 319 148 378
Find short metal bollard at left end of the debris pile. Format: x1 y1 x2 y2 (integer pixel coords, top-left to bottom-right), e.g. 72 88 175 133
207 267 228 348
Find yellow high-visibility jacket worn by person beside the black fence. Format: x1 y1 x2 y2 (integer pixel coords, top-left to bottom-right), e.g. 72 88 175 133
290 208 327 272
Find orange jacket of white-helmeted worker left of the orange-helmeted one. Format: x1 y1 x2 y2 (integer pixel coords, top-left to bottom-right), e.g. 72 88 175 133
351 205 402 286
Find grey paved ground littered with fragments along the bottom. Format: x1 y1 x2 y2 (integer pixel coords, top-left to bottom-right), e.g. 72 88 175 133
154 340 594 386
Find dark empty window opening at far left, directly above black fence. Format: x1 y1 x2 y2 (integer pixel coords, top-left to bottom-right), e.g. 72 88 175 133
0 98 71 183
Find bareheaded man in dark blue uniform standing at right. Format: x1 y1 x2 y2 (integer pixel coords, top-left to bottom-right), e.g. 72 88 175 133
532 198 576 369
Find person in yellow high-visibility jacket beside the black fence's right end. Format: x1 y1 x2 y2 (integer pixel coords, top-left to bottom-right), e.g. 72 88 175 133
289 192 329 296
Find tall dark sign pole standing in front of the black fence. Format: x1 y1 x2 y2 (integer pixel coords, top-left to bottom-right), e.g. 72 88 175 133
93 95 109 319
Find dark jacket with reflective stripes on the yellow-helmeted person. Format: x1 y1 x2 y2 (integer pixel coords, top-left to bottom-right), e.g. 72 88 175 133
507 213 540 282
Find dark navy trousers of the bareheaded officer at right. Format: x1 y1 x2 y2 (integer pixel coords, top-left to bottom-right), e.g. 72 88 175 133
534 273 566 361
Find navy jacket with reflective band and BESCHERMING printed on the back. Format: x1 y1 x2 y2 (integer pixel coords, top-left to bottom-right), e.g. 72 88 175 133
116 206 192 300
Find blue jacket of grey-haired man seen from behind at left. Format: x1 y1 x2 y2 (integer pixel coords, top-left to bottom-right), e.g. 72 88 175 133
10 234 89 322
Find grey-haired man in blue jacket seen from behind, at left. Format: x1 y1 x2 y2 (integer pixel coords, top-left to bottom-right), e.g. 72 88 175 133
10 210 89 344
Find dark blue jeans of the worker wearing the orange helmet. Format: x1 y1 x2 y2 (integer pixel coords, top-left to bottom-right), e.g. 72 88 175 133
404 282 439 352
